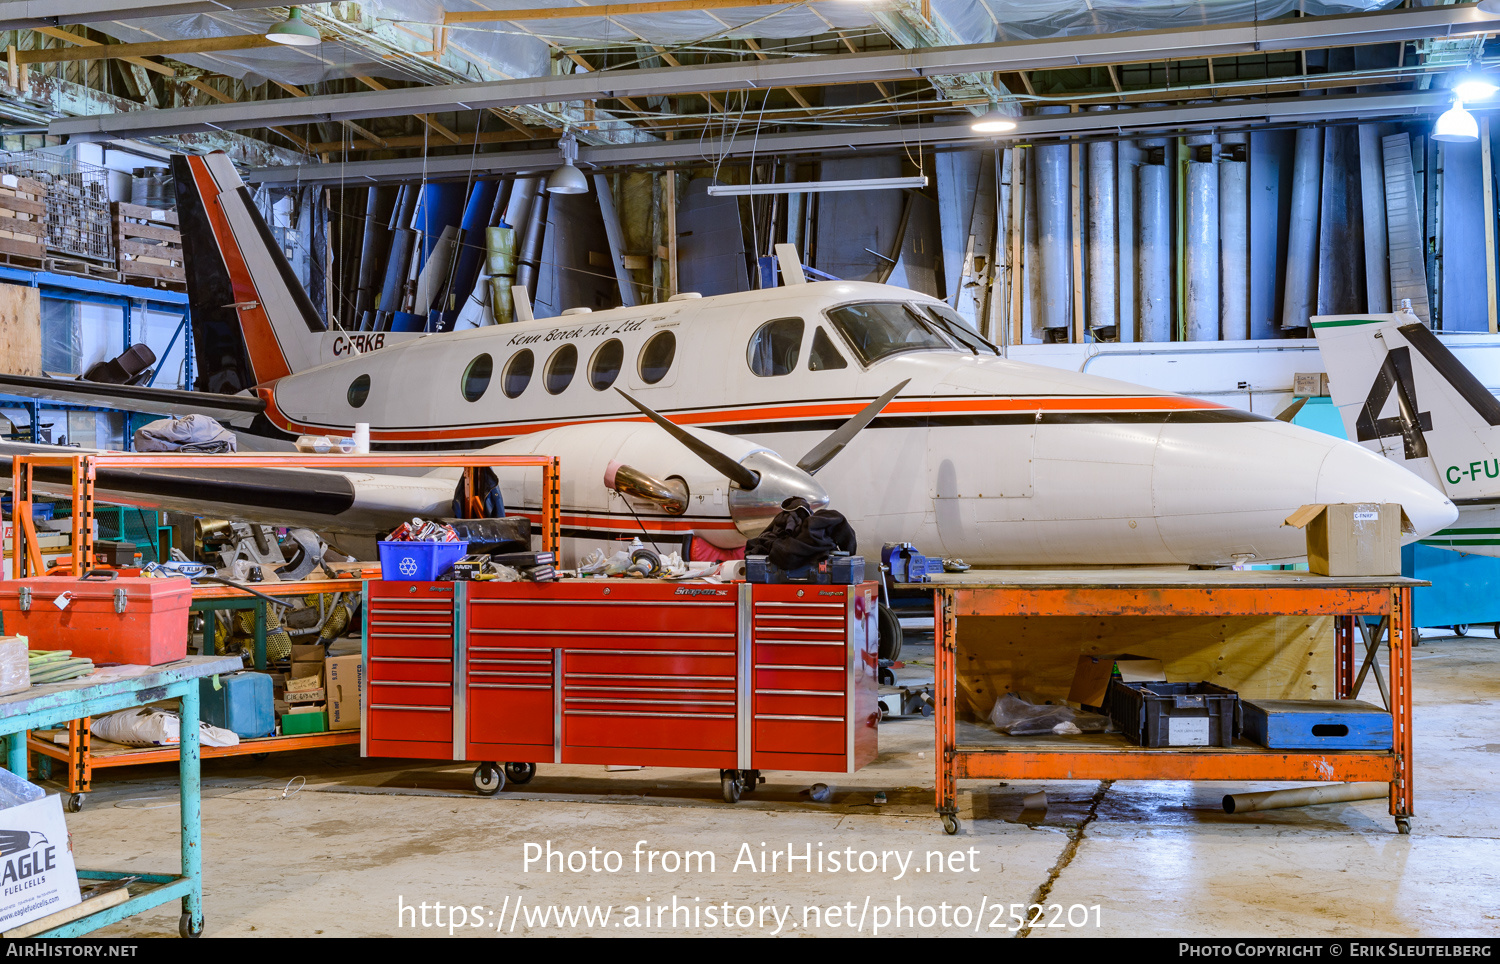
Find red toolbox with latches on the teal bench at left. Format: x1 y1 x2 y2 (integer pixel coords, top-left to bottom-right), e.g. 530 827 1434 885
0 573 192 666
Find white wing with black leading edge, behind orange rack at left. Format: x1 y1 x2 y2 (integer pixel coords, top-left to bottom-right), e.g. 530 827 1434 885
0 442 461 535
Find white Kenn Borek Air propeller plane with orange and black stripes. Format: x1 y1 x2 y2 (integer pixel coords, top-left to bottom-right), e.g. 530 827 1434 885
0 154 1457 565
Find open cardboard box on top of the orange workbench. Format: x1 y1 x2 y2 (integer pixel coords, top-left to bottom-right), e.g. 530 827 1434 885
1286 502 1416 576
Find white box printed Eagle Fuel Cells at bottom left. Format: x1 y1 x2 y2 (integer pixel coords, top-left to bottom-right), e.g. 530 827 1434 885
0 793 83 931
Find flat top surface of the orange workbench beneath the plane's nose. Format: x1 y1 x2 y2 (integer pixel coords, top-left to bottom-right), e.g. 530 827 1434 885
902 568 1431 589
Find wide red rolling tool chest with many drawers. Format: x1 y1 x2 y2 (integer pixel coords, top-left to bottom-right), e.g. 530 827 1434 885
363 580 879 796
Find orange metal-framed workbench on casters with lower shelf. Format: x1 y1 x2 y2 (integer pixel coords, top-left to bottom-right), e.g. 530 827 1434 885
930 570 1427 834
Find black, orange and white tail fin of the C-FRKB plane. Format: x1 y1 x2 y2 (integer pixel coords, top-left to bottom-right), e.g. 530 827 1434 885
173 154 327 394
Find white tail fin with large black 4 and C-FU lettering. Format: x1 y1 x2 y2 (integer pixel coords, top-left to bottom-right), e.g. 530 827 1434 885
1313 310 1500 556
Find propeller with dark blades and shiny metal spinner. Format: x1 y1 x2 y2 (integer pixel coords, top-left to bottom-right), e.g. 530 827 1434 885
615 379 909 537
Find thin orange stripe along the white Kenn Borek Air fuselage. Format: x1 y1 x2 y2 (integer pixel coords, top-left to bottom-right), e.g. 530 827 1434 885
260 388 1229 442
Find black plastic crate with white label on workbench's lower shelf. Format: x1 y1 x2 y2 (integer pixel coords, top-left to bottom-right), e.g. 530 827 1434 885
1107 679 1239 747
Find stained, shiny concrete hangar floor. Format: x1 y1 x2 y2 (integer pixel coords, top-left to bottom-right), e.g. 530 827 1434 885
55 628 1500 939
